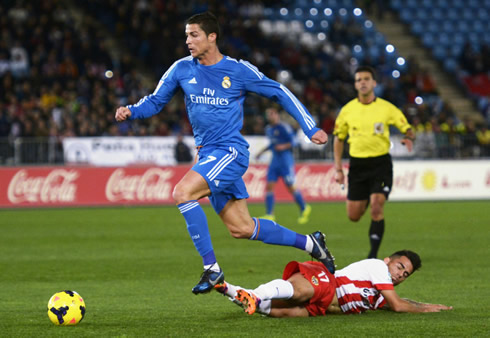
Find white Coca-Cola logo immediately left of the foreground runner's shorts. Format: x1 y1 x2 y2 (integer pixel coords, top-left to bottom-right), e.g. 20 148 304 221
105 168 174 202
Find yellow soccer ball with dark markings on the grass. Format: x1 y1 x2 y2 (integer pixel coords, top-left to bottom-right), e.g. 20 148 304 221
48 290 85 325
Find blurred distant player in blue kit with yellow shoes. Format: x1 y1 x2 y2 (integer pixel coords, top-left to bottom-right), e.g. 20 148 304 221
256 107 311 224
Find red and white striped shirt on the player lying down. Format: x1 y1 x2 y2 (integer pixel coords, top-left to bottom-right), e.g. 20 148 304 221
335 259 393 313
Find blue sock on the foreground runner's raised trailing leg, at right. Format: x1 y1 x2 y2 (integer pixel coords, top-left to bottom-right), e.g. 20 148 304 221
250 217 306 250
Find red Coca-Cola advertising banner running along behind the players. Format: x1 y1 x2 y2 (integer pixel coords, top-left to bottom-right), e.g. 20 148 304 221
0 165 346 207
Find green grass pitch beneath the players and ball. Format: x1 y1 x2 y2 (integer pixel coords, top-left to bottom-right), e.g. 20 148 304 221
0 201 490 337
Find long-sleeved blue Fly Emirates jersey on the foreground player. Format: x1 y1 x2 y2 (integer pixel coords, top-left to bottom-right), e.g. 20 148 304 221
128 56 319 153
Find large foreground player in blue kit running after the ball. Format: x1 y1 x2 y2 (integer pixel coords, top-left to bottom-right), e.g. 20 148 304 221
116 12 335 294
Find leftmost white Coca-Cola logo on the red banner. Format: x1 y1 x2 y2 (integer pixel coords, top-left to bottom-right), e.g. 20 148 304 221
7 169 79 204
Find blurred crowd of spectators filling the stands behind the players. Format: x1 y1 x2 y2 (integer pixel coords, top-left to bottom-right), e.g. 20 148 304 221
0 0 490 161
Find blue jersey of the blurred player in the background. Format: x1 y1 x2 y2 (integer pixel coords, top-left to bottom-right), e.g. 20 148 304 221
265 122 295 166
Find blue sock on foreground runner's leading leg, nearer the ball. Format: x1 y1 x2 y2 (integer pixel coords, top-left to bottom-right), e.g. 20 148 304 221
178 201 216 265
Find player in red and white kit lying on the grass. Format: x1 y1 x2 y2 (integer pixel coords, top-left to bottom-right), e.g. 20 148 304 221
215 250 452 317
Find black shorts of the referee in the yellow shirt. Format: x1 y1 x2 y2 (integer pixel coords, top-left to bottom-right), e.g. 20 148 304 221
347 154 393 201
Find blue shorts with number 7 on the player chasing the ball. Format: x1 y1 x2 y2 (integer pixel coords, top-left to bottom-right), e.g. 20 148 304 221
192 147 248 214
